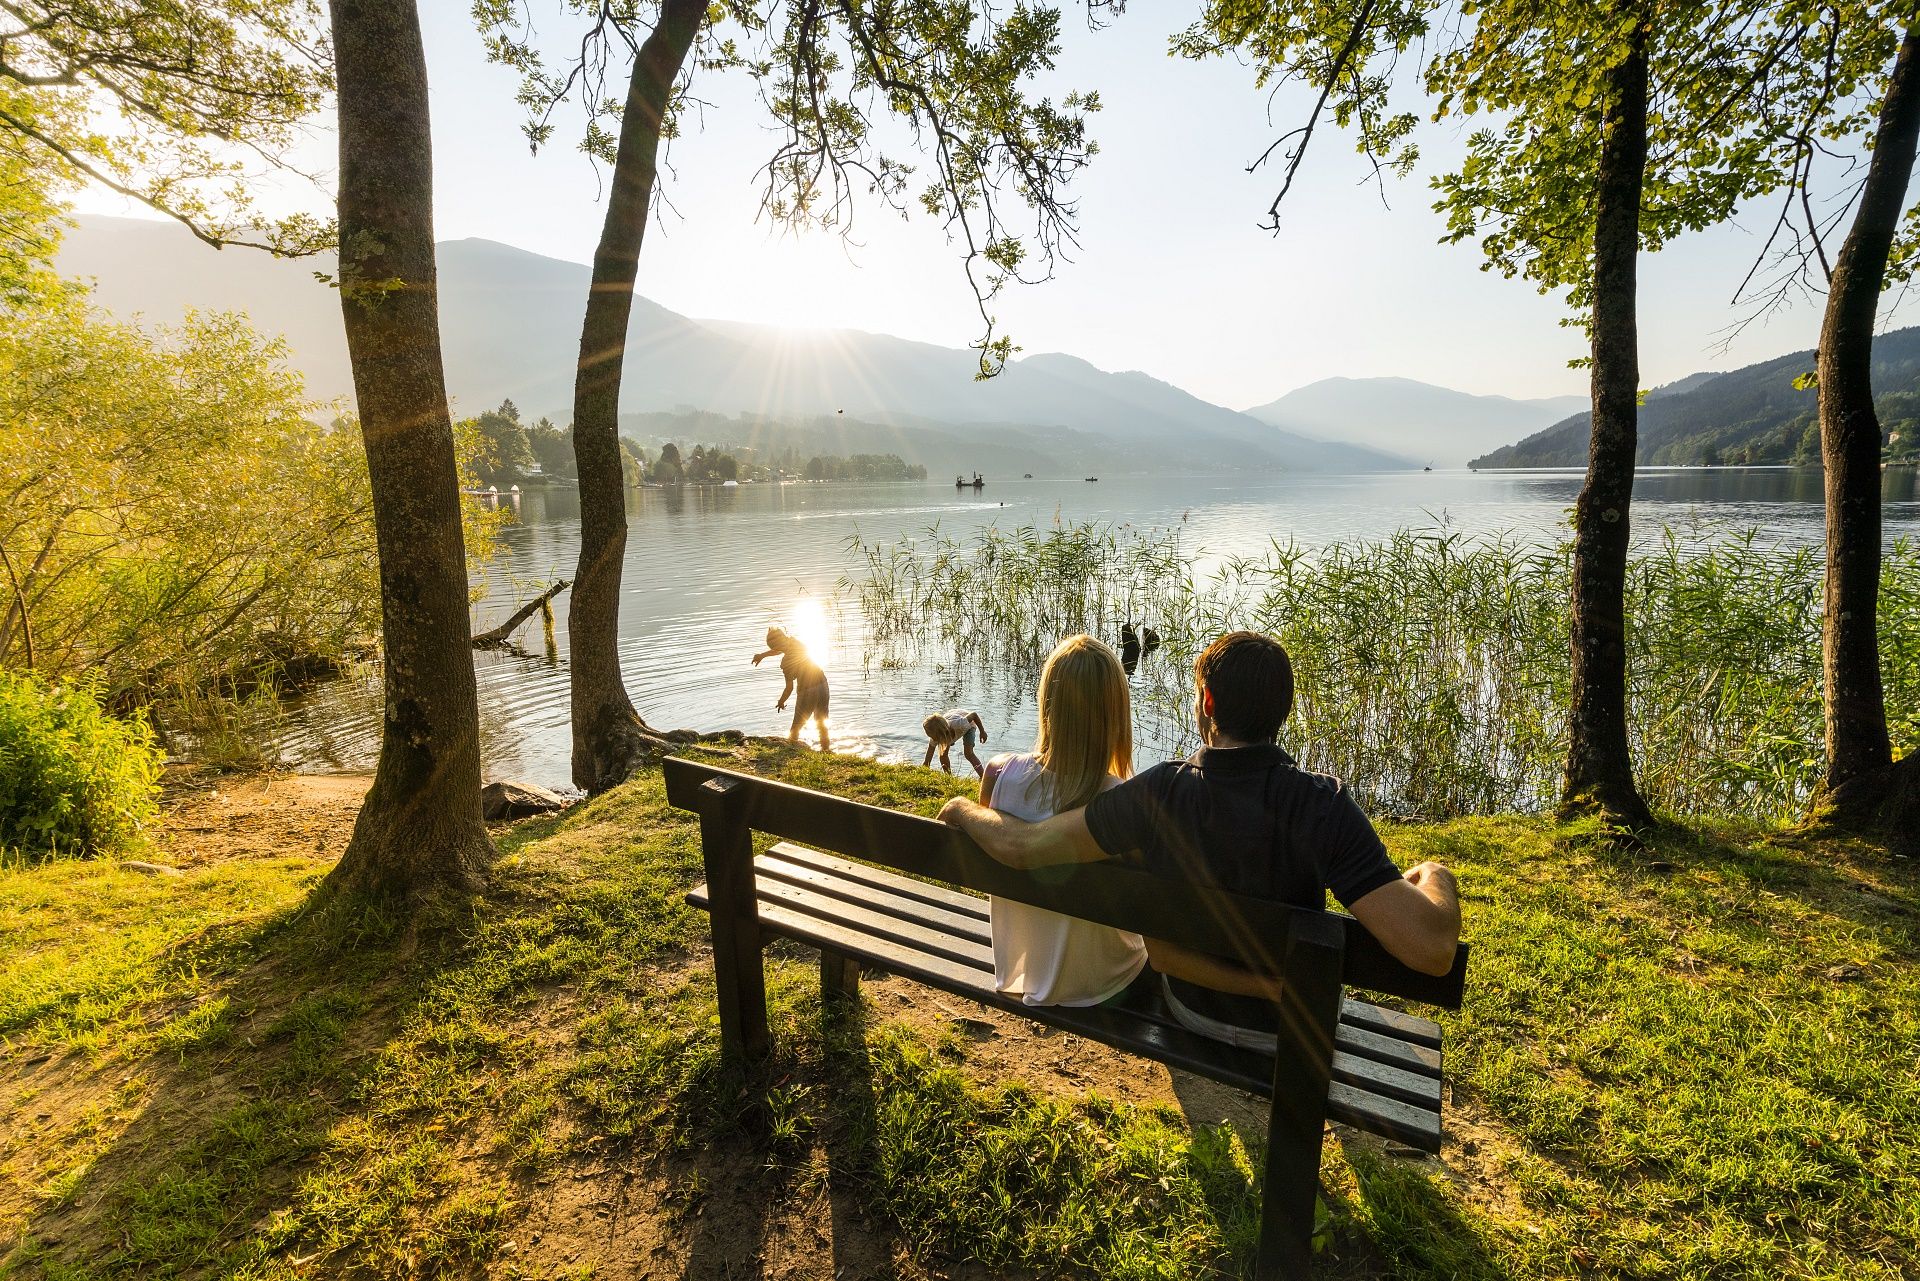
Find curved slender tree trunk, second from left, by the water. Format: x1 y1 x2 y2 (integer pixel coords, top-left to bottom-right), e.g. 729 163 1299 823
566 0 707 793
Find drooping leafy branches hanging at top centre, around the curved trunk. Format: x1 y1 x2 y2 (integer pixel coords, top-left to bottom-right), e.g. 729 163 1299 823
474 0 1102 376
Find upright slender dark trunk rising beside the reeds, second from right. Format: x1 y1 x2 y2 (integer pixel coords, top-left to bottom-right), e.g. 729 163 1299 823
1561 25 1653 828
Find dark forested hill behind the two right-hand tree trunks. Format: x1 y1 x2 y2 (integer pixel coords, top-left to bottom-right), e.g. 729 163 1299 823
1471 328 1920 467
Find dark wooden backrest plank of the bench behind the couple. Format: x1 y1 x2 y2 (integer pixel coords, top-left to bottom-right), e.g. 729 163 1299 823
662 757 1467 1008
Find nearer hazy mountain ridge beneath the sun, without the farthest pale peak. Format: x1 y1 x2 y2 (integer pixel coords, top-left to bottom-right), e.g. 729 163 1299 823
60 217 1413 472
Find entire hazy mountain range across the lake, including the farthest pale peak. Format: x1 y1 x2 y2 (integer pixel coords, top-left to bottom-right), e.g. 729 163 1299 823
60 217 1620 474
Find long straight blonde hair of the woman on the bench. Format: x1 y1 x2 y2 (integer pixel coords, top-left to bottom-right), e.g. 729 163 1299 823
1033 634 1133 812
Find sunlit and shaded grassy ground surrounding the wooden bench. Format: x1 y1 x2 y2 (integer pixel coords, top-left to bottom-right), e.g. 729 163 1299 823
0 749 1920 1281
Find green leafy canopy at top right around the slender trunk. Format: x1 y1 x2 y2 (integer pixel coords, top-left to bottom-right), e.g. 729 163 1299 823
1175 0 1920 330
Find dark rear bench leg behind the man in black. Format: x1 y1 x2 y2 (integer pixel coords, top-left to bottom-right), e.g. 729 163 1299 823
1254 918 1344 1281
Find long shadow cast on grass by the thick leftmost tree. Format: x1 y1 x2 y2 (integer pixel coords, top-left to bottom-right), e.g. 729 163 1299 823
0 908 487 1277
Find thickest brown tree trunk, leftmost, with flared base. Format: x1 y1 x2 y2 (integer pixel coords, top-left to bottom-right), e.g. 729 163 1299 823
326 0 492 899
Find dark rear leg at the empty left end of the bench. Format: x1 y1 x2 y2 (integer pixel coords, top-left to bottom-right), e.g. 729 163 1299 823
701 778 772 1062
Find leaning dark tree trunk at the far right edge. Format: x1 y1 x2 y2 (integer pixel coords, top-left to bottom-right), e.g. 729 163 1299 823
1818 27 1920 828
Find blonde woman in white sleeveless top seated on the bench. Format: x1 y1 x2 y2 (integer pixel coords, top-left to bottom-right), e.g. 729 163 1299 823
979 636 1146 1004
